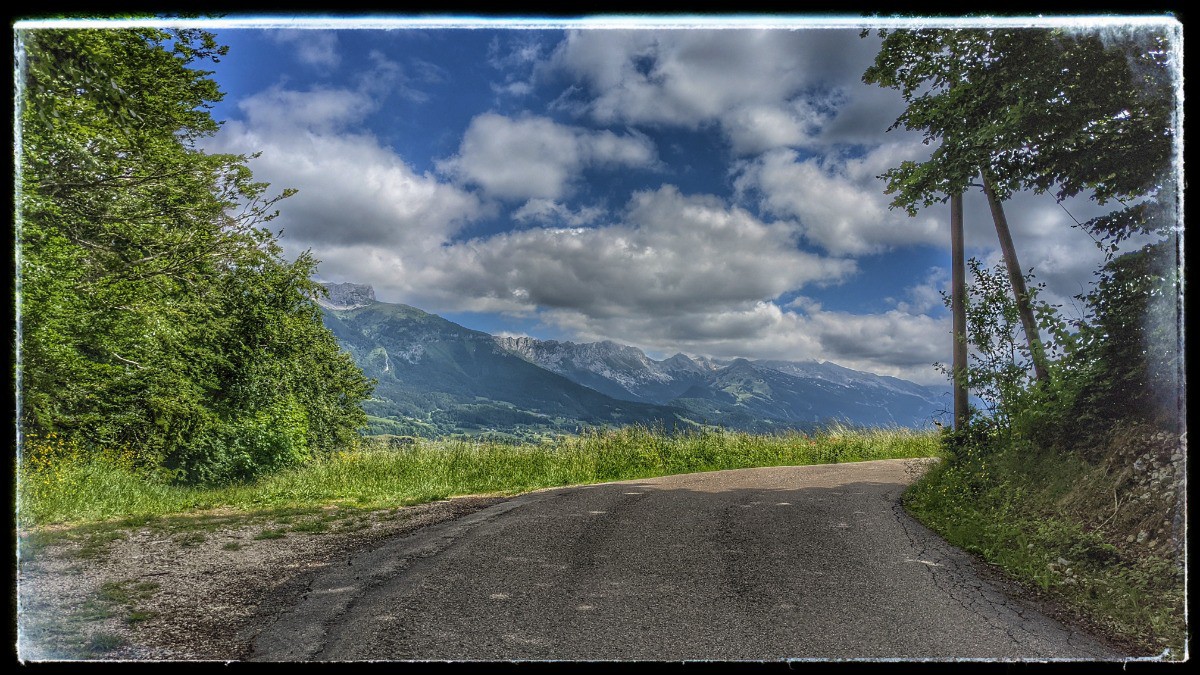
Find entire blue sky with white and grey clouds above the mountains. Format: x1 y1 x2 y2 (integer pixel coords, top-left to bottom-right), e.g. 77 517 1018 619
171 22 1171 383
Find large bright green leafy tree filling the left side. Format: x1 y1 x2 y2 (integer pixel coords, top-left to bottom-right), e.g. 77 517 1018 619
17 24 370 482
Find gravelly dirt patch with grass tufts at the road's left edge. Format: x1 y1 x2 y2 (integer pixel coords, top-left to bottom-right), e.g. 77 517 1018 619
17 497 506 661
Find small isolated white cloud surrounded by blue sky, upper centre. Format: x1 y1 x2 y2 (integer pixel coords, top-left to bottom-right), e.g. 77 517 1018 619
438 113 656 199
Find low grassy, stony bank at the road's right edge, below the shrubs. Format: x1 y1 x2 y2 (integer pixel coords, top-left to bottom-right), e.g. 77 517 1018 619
905 425 1187 659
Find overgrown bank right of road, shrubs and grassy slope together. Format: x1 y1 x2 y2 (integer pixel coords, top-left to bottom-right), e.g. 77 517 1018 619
905 241 1186 653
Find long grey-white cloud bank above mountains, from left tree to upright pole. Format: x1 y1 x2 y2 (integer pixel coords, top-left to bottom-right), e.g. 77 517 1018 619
217 92 946 382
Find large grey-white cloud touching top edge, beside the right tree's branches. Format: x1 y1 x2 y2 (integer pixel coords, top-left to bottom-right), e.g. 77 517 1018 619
538 30 895 155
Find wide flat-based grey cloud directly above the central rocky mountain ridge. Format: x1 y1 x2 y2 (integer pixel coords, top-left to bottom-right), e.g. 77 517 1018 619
384 185 949 382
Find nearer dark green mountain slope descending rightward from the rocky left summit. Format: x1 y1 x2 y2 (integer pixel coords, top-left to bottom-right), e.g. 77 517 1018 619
322 291 684 436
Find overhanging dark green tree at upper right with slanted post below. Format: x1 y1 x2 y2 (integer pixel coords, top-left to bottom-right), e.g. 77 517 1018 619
863 29 1176 391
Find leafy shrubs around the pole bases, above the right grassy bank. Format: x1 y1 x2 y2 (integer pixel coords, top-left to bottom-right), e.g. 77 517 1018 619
938 236 1183 453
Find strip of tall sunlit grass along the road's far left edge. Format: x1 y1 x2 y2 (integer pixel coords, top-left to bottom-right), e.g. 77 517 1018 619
18 426 940 526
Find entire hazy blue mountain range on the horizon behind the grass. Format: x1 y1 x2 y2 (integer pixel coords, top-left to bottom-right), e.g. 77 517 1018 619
322 283 949 436
